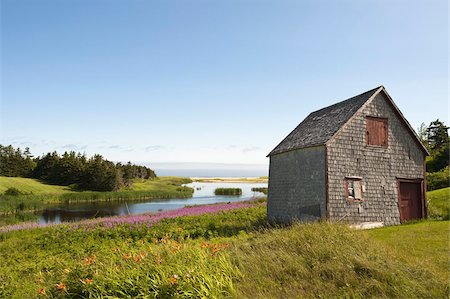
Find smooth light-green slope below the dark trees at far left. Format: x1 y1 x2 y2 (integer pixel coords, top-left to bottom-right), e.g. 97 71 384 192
0 176 72 194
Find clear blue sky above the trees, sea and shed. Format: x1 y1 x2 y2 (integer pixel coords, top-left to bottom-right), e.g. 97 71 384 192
0 0 449 164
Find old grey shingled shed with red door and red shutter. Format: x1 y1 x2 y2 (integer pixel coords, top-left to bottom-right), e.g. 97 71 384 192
267 86 428 225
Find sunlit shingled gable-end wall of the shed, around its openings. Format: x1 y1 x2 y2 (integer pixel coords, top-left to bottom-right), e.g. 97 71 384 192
327 92 424 225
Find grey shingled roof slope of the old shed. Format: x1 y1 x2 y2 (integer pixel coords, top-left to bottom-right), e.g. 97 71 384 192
268 86 382 156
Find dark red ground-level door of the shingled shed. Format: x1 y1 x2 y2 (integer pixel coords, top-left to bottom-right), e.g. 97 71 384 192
399 182 422 221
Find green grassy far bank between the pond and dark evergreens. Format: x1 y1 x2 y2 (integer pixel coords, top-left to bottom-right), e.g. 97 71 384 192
0 177 194 217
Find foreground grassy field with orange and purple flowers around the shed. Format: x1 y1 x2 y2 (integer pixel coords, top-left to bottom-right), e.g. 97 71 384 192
0 199 450 298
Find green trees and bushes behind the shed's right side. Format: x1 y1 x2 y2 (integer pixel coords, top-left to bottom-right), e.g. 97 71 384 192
418 119 450 190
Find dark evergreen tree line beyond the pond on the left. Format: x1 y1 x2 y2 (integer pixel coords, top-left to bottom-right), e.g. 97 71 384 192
0 145 156 191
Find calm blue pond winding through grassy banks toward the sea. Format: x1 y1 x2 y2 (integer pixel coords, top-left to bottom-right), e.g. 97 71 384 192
38 182 267 223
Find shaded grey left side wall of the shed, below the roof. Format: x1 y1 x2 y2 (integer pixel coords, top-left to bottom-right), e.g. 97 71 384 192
267 146 326 223
